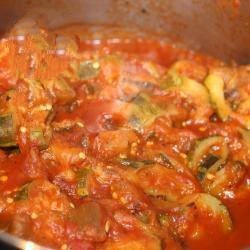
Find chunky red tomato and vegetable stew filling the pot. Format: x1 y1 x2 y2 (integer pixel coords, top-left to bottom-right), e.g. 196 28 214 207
0 23 250 250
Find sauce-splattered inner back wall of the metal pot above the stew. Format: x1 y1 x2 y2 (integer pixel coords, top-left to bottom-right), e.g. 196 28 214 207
0 0 250 63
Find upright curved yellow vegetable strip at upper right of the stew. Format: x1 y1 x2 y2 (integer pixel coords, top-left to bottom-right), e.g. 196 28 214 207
204 74 231 121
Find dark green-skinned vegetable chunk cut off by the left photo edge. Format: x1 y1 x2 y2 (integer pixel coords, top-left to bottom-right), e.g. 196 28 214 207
0 114 17 148
